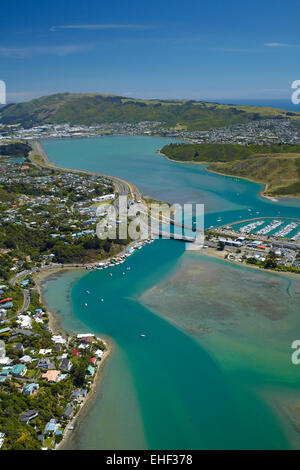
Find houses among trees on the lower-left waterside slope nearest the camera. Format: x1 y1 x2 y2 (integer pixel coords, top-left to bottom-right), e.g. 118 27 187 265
0 326 106 448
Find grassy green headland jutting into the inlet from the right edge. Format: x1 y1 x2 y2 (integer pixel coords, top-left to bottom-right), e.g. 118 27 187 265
161 144 300 197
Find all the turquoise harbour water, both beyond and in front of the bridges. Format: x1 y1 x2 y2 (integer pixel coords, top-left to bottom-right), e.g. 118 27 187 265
44 137 300 449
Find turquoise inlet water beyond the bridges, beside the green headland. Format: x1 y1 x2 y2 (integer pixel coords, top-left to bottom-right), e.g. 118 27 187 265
43 136 300 225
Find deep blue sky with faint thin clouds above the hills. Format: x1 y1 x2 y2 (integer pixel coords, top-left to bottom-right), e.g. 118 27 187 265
0 0 300 102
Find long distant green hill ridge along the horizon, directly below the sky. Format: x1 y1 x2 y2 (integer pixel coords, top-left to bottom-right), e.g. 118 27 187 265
0 93 300 130
